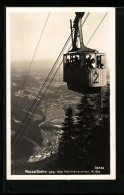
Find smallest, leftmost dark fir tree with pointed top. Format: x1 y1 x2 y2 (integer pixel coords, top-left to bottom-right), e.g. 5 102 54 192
58 107 75 169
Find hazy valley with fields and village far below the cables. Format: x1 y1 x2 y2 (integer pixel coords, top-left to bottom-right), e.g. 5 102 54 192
11 66 109 174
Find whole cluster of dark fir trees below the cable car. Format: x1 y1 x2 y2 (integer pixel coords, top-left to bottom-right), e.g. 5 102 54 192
58 89 110 173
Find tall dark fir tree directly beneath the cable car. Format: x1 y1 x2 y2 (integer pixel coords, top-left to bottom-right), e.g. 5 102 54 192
76 95 96 167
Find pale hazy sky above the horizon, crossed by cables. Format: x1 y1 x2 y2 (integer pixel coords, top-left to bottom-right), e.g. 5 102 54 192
10 10 109 69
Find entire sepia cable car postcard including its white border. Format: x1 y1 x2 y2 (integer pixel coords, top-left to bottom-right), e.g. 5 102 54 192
6 7 116 180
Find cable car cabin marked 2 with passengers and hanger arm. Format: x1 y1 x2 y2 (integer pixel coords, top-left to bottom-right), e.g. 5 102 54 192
63 12 106 93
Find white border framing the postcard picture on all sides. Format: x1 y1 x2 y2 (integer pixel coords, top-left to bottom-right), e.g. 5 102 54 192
6 7 116 180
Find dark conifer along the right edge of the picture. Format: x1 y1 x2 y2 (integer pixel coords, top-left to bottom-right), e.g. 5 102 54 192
88 86 110 174
